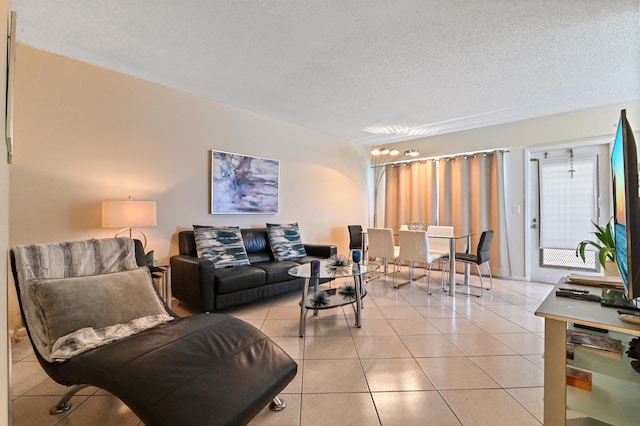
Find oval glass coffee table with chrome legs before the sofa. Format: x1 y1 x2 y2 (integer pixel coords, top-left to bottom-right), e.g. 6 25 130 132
288 261 380 337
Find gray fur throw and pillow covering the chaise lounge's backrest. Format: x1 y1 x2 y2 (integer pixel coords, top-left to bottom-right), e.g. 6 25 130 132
13 238 172 362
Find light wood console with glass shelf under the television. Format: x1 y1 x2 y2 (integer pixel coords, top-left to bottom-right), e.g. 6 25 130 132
536 280 640 425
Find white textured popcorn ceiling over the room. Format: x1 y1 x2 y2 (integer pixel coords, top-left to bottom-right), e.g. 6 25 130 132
12 0 640 145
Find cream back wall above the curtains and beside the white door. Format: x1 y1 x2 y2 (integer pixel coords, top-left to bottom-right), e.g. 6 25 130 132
395 100 640 279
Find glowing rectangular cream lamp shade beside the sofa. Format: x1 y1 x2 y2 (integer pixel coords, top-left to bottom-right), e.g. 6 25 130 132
102 200 157 228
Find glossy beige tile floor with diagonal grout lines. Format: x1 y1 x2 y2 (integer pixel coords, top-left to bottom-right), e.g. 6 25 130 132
12 272 553 426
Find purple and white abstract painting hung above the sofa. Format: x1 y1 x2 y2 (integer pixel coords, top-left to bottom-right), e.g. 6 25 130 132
211 150 280 214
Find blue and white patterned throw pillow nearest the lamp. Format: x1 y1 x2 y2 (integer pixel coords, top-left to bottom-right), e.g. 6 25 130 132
193 225 250 269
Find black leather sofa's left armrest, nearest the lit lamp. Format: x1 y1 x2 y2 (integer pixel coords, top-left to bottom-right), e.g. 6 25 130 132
169 254 215 312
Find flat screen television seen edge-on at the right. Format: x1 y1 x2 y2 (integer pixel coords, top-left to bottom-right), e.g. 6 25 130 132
611 110 640 300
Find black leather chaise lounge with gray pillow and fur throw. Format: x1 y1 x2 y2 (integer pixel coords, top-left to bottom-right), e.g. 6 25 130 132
11 238 297 425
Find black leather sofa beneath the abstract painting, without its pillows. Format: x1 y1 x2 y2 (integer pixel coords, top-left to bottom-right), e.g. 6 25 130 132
170 228 337 312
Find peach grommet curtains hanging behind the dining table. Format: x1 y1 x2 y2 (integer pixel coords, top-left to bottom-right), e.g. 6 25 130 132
384 151 511 276
